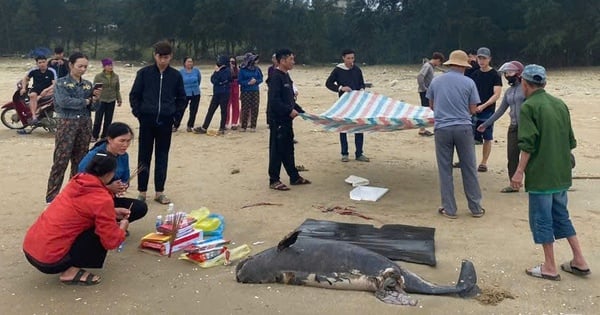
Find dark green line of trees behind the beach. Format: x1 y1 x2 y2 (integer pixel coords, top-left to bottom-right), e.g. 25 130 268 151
0 0 600 66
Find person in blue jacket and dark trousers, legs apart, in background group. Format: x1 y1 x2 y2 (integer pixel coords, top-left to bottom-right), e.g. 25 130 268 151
194 56 233 135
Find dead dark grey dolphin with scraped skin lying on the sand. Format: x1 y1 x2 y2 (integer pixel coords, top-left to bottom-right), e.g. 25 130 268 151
236 231 480 305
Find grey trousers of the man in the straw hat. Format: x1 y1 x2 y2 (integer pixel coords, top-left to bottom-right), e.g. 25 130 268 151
435 125 481 215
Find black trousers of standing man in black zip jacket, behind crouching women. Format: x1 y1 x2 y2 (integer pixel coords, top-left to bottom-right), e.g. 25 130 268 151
138 116 173 192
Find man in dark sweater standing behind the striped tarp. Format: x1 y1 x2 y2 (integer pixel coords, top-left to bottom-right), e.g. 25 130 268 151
325 49 370 162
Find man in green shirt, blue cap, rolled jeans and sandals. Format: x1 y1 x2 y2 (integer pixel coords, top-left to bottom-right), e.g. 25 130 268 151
511 65 591 281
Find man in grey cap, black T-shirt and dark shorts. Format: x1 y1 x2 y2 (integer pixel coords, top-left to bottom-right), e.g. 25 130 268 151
470 47 502 172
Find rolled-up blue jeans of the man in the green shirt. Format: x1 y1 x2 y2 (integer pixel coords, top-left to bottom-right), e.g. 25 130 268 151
529 191 575 244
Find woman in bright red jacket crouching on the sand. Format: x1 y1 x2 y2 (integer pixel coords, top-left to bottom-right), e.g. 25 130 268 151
23 152 129 285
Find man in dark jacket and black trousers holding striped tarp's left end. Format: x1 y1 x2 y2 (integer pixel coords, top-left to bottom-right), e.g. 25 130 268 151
267 49 310 190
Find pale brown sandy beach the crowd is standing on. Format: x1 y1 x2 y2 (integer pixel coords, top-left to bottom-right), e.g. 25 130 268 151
0 59 600 315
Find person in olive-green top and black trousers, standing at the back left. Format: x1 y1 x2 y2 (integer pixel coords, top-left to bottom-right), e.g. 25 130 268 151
92 58 123 142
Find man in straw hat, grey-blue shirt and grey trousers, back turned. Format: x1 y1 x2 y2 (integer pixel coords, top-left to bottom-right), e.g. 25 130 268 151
426 50 485 219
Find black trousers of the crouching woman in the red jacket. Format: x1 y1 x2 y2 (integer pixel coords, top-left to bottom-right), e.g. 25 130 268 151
25 228 106 274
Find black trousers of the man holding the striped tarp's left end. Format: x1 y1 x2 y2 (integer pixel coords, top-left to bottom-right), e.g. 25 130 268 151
269 123 300 184
